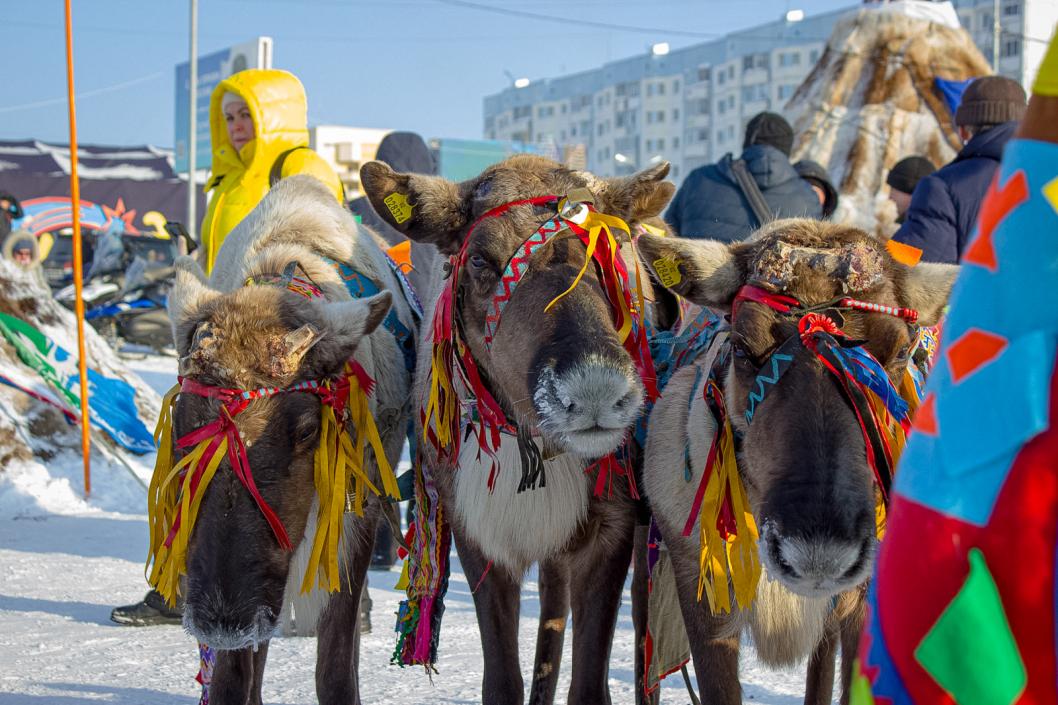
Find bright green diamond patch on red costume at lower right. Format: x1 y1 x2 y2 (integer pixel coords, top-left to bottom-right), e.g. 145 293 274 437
915 548 1027 705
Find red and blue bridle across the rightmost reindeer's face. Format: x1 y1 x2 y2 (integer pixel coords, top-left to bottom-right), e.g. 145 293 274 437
731 285 918 501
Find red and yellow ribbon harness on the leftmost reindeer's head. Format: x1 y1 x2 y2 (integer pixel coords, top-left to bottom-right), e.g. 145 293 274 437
146 260 400 604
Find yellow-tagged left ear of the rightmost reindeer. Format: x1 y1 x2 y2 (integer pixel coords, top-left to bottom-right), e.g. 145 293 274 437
636 235 745 309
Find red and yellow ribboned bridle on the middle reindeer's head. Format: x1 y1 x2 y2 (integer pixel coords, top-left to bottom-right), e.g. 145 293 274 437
421 193 657 495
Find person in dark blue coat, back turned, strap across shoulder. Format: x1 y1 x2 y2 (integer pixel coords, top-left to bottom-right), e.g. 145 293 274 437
664 112 823 241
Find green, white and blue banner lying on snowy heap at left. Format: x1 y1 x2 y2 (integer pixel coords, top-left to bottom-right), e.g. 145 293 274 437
0 313 154 453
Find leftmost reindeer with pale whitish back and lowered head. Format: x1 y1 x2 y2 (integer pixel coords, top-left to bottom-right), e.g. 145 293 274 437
156 171 417 705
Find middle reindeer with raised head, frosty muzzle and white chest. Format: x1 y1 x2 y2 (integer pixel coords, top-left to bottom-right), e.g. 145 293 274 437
361 156 673 705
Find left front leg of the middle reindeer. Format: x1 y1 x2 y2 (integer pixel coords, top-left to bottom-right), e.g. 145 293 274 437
452 523 525 705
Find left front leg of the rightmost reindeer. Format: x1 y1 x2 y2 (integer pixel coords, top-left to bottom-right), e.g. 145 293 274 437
660 524 742 705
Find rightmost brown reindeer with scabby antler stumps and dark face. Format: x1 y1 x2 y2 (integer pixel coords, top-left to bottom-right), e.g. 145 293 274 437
639 219 957 705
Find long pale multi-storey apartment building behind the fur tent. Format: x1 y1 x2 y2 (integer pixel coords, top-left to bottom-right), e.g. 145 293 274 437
484 0 1058 182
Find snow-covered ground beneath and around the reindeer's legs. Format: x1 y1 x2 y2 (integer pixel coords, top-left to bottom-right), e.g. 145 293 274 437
0 349 804 705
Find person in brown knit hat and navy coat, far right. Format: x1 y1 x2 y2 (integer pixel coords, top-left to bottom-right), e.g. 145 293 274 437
893 76 1025 265
